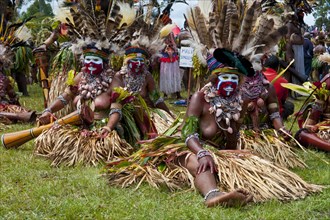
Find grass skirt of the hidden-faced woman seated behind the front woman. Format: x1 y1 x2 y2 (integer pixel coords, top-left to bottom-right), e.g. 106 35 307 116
240 129 306 168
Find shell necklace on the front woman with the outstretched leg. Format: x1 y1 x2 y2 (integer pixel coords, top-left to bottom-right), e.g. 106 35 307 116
202 83 243 134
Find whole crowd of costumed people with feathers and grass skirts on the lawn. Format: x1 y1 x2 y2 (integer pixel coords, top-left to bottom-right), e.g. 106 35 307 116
0 1 330 207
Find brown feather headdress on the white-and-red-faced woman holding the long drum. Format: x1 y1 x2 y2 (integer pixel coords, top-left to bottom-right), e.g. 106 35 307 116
66 3 136 59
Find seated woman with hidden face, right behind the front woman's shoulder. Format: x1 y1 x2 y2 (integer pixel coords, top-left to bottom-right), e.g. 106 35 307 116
240 54 305 167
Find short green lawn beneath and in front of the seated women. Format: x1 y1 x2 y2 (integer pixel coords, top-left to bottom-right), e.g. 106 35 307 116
0 85 330 220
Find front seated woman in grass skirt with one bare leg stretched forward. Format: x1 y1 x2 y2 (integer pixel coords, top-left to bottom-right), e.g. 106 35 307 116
106 3 322 207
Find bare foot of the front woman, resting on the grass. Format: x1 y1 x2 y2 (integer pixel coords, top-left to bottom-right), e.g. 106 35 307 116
205 189 253 208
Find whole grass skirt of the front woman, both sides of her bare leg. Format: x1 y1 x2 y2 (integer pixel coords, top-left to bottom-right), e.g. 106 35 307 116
105 136 322 202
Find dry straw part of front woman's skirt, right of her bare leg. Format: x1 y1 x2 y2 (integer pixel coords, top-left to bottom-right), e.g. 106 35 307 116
212 151 323 202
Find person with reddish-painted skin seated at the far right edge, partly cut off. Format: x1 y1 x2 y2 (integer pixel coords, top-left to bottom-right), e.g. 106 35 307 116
295 74 330 152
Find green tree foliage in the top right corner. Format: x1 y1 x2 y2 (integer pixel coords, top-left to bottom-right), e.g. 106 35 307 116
313 0 330 31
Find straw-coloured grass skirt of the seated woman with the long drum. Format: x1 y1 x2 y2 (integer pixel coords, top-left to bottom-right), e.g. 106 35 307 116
34 125 133 166
